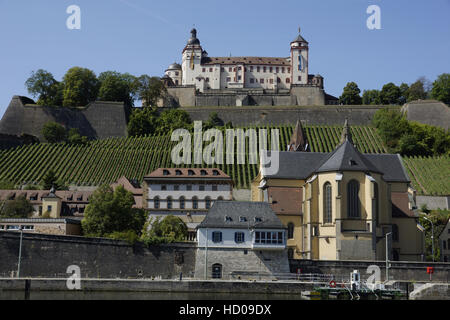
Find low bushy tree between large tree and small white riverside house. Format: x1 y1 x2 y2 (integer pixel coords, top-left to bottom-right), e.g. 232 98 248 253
141 215 188 245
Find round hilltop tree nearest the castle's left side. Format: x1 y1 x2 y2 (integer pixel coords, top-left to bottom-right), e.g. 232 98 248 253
134 74 167 107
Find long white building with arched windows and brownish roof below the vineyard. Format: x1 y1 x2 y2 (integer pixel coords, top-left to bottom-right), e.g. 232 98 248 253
143 168 233 239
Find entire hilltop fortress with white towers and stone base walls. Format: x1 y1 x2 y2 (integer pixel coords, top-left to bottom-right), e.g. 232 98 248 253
160 29 338 106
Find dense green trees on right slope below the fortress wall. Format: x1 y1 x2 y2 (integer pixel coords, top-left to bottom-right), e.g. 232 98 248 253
372 108 450 156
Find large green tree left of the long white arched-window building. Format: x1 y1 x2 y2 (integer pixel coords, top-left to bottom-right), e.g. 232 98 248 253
81 185 146 237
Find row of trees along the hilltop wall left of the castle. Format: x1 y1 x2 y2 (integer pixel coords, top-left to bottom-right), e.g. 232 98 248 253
25 67 165 110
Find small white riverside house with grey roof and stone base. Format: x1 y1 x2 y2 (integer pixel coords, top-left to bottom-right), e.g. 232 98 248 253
195 201 289 279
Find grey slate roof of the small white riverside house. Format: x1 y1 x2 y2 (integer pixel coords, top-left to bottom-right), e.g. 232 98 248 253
197 201 285 229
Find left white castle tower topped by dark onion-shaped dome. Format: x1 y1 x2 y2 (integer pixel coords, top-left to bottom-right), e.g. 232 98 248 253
181 28 203 85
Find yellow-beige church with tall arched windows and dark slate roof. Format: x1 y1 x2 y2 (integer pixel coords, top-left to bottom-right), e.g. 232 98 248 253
252 121 424 261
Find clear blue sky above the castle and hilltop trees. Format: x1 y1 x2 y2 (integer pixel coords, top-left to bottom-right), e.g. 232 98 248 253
0 0 450 116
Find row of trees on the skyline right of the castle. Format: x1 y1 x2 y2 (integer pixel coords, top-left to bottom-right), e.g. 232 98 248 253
339 73 450 105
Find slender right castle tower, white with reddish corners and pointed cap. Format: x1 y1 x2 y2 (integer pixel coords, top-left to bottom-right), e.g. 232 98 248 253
291 28 308 84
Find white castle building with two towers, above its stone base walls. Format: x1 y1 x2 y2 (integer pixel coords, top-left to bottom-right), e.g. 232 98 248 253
165 29 323 92
